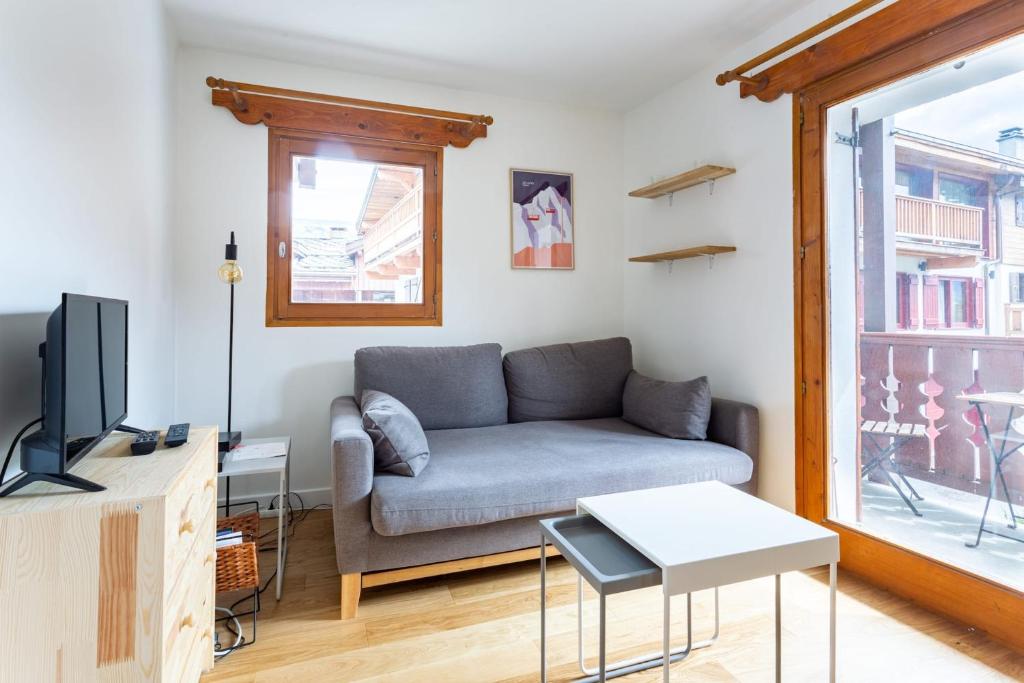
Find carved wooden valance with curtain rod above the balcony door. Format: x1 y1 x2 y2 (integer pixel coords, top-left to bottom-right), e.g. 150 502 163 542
716 0 1024 102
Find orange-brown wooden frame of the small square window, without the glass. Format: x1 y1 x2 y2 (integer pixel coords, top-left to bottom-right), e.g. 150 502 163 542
266 128 444 327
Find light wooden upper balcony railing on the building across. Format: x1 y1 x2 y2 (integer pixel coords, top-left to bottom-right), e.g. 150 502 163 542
859 191 985 249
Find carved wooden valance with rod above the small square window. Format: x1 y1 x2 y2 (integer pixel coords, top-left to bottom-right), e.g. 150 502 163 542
206 76 494 147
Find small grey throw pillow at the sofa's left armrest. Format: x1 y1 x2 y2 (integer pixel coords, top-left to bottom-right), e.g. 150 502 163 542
360 390 430 477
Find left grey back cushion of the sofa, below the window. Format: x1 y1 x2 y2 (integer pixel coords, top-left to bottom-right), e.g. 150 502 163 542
355 344 508 429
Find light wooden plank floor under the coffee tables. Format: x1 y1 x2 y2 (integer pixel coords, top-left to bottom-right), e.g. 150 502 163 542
203 511 1024 683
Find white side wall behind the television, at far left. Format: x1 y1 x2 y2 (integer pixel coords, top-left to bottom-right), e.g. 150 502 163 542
0 0 174 481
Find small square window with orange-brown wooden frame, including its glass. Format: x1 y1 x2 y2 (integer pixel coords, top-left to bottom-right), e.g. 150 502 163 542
268 131 441 325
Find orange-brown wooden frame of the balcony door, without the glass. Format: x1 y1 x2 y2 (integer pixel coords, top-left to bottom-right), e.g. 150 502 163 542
793 1 1024 650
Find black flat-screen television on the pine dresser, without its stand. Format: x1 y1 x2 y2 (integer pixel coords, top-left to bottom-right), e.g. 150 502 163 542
58 294 128 468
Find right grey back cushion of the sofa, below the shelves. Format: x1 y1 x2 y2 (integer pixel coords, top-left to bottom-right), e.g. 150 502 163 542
503 337 633 422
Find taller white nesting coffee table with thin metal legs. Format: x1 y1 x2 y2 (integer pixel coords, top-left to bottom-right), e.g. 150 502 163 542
569 481 839 682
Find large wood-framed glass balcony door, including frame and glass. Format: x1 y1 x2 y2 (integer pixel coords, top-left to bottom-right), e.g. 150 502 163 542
797 13 1024 646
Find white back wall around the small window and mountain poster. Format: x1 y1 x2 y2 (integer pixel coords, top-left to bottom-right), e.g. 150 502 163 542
174 47 624 502
